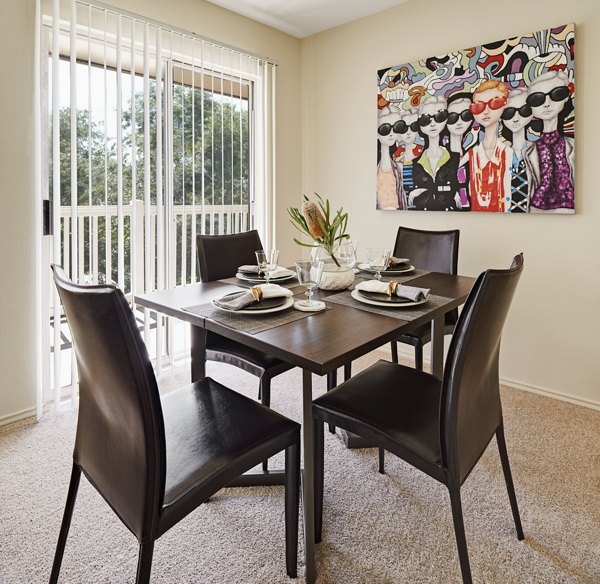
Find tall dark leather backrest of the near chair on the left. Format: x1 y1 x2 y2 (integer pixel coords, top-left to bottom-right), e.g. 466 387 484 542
52 266 166 538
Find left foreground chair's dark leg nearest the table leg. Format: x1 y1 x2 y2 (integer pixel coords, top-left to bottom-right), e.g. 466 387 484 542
285 443 300 578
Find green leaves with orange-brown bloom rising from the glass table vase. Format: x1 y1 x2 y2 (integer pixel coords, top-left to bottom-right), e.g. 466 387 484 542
287 193 350 267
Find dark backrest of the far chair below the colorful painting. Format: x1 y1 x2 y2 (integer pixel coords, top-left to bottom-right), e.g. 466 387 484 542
394 226 460 274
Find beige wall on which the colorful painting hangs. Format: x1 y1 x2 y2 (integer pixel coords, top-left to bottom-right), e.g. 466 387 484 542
302 0 600 407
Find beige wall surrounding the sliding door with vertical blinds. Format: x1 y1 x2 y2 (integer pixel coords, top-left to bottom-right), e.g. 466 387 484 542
0 0 300 425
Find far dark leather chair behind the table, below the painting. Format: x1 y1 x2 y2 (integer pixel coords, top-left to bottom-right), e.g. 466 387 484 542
391 226 460 371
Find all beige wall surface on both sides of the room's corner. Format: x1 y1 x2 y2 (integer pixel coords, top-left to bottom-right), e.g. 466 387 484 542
0 0 600 424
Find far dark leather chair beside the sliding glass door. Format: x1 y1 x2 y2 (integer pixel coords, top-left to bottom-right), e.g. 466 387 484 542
196 230 293 412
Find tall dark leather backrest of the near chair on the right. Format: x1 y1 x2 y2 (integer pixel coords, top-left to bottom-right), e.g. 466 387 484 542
441 254 523 484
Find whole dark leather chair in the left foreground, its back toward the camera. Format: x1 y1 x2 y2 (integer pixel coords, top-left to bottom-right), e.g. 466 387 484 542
50 266 300 584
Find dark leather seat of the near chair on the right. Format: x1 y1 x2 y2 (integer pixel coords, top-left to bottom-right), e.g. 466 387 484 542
313 361 441 465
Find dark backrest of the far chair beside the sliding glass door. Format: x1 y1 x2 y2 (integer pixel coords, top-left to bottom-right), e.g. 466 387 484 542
196 230 263 282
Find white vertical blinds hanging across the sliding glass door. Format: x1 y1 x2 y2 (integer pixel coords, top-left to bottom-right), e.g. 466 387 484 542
36 0 275 414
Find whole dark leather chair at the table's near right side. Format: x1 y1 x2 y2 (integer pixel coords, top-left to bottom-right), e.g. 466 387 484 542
313 254 524 584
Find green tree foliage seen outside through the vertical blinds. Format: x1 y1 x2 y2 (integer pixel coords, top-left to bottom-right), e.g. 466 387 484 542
55 66 250 290
